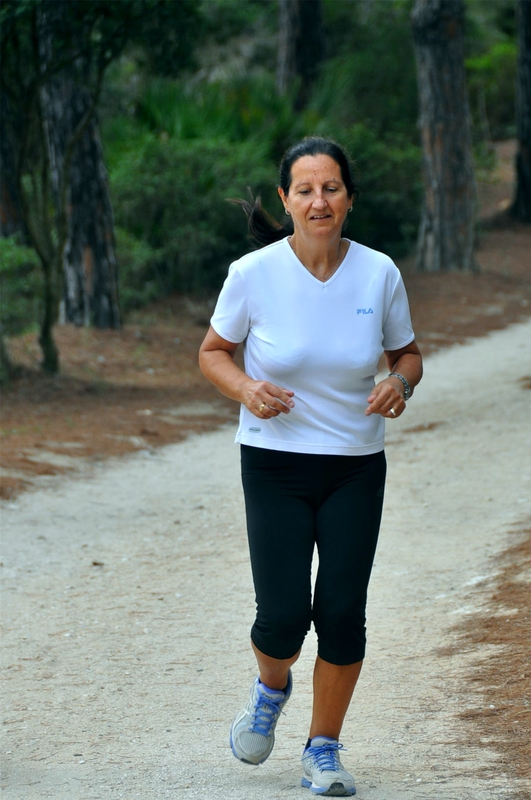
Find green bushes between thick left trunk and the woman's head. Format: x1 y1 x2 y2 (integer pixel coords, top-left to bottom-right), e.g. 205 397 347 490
104 76 304 294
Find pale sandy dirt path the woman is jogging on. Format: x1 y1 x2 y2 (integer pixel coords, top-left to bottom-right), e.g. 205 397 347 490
2 322 531 800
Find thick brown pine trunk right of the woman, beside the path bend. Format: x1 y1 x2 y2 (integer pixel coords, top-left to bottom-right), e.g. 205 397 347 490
412 0 477 272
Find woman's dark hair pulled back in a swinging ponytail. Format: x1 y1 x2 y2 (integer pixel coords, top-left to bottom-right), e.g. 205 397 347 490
232 136 359 245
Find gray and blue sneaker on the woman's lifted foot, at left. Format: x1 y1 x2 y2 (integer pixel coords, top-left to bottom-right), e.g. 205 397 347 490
230 671 293 764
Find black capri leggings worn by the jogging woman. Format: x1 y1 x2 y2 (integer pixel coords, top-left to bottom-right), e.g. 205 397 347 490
241 445 386 664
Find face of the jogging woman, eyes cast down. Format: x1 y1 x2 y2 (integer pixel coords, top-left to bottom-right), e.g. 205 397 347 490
278 155 353 238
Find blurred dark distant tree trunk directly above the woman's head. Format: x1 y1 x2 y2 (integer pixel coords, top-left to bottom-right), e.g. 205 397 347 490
277 0 325 111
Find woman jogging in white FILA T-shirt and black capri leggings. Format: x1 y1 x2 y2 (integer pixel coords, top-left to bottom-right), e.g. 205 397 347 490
200 137 422 797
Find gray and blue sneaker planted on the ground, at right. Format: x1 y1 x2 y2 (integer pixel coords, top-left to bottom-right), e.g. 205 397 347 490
301 736 356 797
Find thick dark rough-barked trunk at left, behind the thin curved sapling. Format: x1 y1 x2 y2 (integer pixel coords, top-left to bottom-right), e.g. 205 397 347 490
43 0 120 328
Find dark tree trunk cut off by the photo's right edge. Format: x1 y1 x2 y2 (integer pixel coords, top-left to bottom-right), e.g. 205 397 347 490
511 0 531 222
